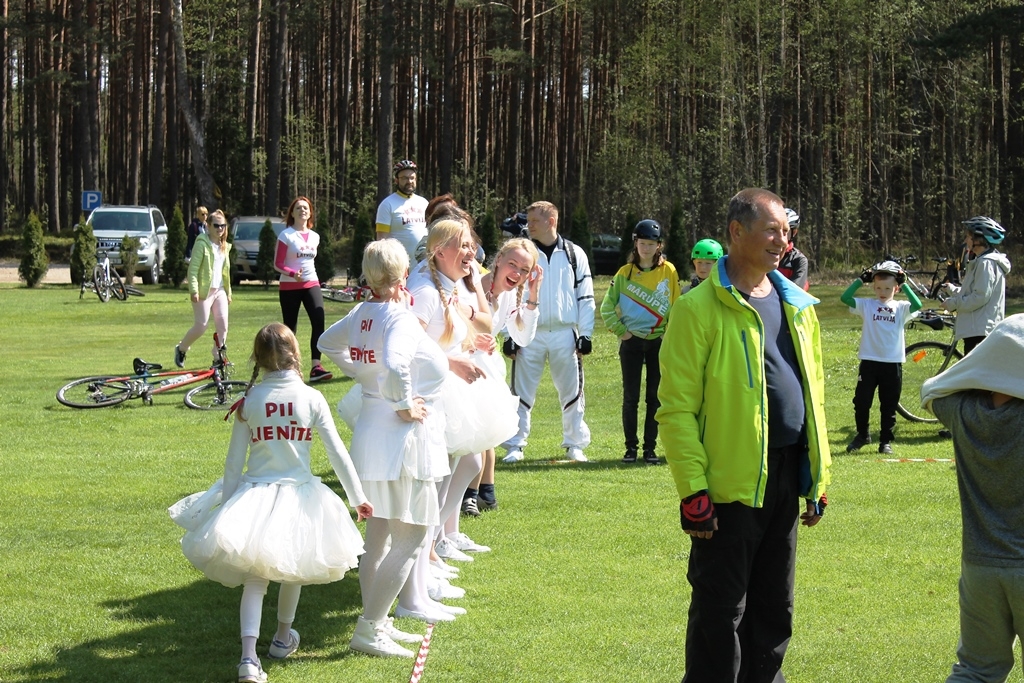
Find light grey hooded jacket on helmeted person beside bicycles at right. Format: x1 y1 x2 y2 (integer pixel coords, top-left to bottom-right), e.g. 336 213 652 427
943 249 1010 339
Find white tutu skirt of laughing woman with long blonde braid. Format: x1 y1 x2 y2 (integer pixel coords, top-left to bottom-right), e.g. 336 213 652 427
441 368 519 458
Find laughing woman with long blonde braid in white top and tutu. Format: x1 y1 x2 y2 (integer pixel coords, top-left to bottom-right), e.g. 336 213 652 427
409 218 518 561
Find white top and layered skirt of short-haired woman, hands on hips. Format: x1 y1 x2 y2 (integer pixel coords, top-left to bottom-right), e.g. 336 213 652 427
317 302 450 525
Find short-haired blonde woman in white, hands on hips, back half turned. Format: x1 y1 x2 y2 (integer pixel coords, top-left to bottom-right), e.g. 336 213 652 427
319 239 449 656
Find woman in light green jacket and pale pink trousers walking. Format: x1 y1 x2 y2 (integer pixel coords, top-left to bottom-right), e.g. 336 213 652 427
174 210 231 368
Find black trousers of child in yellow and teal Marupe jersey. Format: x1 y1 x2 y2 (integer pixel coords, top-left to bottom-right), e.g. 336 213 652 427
618 337 662 453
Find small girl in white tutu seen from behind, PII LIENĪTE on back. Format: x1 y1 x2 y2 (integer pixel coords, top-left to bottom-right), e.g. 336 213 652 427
169 323 374 683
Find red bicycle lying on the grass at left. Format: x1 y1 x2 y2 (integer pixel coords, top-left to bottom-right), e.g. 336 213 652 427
57 336 248 411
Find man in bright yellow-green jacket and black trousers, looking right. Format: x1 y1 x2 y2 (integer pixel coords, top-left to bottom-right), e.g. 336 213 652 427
657 188 831 683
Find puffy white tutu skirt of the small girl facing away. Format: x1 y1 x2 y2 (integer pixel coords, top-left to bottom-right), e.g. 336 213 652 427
168 477 362 588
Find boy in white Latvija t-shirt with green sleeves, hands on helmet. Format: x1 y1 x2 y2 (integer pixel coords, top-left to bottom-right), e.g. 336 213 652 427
840 261 921 455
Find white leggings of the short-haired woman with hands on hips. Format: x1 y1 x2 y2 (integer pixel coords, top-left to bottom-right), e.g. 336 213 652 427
359 517 427 622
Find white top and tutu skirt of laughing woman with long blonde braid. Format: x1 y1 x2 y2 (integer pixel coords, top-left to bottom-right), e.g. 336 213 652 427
409 262 519 458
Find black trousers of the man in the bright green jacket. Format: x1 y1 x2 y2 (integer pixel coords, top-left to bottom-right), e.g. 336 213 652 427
683 446 802 683
